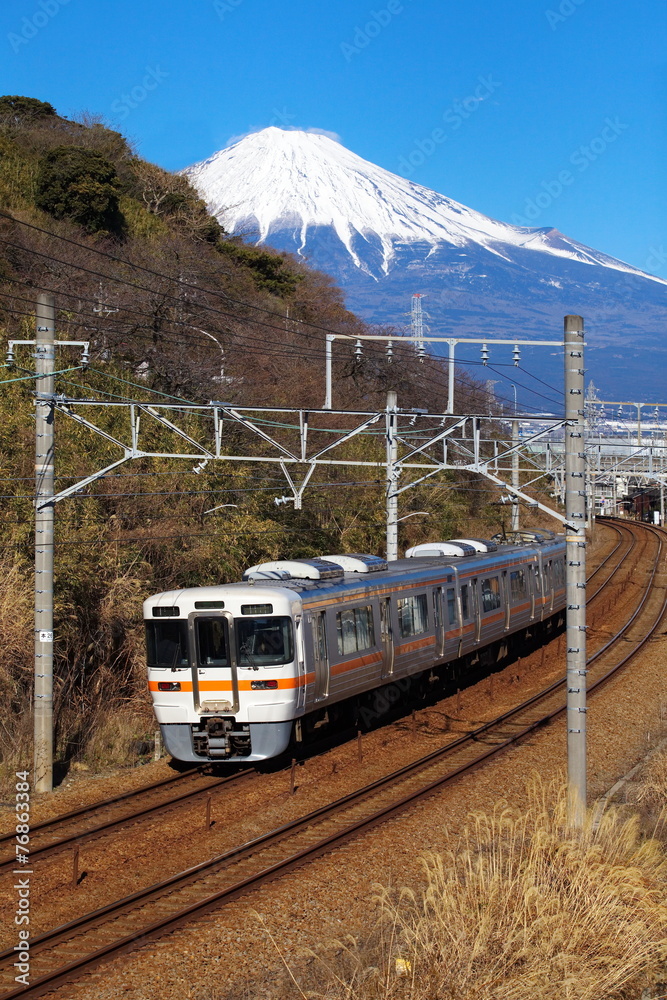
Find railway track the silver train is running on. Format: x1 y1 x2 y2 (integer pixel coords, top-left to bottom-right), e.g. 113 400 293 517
0 523 634 875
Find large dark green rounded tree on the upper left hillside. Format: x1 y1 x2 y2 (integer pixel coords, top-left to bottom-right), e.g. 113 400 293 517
35 146 125 236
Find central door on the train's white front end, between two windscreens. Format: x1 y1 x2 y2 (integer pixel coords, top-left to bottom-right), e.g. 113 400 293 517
188 611 239 713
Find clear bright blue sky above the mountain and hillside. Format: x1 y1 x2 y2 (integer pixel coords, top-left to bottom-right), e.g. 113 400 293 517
0 0 667 278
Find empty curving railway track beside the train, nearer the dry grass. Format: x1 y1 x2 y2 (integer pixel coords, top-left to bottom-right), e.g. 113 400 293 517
0 525 667 1000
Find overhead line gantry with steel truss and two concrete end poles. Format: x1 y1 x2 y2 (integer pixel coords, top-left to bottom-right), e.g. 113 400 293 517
15 296 586 826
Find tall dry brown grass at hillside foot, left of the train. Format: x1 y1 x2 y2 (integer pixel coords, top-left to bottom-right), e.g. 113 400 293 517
0 552 156 795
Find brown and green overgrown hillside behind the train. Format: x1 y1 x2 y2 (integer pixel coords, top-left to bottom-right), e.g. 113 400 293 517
0 97 516 770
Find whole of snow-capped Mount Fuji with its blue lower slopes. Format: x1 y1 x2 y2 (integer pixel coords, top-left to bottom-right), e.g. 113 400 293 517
183 127 667 402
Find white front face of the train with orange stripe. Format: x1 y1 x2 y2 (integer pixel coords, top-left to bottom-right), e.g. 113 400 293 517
144 584 304 763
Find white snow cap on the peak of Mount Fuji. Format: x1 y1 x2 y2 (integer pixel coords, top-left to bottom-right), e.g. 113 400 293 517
183 126 664 282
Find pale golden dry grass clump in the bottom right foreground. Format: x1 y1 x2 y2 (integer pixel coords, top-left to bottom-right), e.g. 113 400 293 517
274 784 667 1000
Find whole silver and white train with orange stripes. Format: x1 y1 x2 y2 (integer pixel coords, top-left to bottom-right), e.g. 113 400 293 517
144 532 565 763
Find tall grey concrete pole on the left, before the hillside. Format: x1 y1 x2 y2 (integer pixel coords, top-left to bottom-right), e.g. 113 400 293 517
33 294 56 792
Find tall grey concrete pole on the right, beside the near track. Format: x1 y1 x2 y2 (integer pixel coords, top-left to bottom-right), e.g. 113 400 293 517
564 316 587 829
